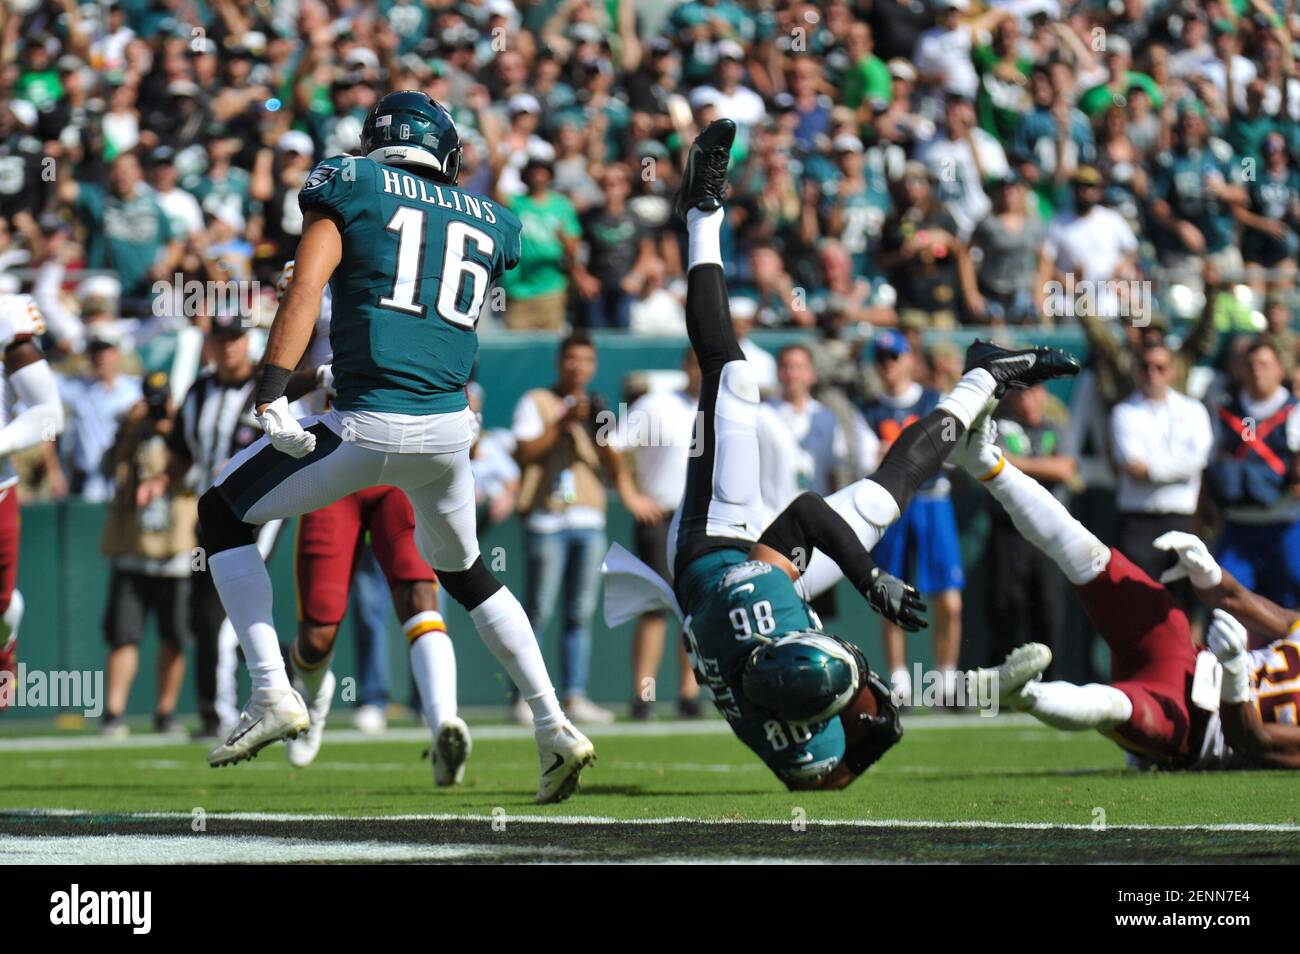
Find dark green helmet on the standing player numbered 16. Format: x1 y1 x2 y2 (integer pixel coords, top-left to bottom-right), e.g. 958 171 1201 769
361 90 462 186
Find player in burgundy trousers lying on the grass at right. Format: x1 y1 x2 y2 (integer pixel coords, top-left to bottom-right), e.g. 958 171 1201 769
952 421 1300 769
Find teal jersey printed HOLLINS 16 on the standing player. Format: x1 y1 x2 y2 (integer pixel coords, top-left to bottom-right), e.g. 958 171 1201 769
298 156 520 415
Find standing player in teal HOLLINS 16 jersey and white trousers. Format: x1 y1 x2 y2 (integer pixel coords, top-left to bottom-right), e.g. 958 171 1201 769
199 91 595 803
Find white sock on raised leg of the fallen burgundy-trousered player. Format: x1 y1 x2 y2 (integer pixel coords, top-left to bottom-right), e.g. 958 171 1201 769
984 459 1110 586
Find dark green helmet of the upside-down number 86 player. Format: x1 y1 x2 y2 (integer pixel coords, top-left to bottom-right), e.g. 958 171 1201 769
742 629 867 723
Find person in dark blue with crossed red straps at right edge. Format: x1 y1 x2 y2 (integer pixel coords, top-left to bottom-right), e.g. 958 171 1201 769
1205 338 1300 606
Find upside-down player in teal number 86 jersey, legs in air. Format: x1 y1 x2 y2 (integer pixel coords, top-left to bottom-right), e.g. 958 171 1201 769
639 120 1079 789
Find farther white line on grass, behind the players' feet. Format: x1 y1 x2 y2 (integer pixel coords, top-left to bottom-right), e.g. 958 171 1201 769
0 712 1040 754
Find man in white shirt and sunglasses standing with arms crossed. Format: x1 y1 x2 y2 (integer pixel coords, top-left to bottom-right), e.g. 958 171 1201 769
1110 344 1214 597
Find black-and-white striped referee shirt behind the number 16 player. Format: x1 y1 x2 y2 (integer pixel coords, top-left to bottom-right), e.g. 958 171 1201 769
172 372 261 494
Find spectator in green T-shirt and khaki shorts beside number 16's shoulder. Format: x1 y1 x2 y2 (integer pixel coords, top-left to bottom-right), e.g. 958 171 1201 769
502 157 577 331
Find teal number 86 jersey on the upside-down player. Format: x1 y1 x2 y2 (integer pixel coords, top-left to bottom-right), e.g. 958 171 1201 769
676 548 845 782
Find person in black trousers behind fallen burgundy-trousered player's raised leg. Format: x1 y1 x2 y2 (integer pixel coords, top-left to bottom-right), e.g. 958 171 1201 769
984 385 1078 664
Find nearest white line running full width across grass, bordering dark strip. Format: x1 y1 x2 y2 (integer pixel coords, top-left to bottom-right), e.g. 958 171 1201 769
12 808 1300 837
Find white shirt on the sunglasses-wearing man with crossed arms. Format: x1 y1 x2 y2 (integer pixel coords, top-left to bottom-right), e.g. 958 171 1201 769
1110 390 1214 513
